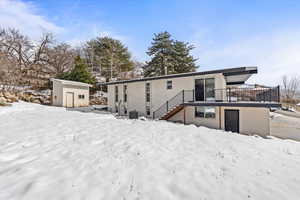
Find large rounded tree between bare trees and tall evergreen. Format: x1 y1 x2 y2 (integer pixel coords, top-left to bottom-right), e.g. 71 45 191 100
84 37 133 79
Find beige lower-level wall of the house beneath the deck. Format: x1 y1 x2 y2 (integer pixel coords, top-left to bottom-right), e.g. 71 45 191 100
169 106 270 136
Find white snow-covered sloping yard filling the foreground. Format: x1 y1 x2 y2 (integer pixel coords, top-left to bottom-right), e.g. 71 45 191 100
0 103 300 200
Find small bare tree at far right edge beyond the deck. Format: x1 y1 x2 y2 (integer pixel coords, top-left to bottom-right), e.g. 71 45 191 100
282 75 300 101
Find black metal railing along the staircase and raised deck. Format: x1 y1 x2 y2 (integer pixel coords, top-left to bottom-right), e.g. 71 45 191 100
153 86 280 119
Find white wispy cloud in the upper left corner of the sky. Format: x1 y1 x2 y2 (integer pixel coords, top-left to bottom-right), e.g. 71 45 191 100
0 0 64 39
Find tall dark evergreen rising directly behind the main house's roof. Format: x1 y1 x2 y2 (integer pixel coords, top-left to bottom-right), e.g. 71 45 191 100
143 31 197 77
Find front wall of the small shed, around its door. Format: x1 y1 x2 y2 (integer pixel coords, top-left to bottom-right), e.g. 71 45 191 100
63 85 90 107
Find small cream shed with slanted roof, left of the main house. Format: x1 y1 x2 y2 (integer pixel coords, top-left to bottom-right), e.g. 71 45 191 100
51 79 91 108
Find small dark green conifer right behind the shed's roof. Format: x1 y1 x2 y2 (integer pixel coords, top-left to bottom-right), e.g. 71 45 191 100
57 56 95 84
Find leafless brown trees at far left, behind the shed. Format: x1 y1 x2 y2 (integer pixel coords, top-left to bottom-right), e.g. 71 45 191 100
0 29 75 87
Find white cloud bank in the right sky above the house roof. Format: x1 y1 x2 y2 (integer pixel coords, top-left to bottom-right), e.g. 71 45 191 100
194 30 300 85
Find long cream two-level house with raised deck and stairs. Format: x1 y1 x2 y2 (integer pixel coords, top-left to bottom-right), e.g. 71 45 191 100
101 67 280 136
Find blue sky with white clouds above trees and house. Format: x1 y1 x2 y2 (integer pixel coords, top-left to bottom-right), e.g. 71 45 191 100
0 0 300 86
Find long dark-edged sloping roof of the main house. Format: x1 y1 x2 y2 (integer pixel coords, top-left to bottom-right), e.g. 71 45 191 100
98 67 257 85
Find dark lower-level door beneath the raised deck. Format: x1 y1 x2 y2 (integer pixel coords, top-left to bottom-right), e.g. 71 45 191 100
225 109 240 133
